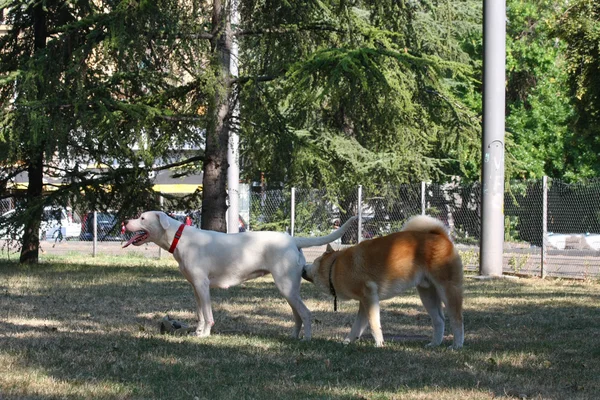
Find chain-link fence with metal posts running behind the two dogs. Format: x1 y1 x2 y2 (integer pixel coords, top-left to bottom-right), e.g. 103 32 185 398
0 179 600 278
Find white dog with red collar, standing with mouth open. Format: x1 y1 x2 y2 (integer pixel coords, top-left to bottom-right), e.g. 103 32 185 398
123 211 356 340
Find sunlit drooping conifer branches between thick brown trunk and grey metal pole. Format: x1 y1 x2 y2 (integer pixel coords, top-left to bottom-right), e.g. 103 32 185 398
241 1 479 192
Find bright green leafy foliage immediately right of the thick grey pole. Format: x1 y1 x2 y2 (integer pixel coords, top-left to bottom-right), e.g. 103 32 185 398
506 0 574 178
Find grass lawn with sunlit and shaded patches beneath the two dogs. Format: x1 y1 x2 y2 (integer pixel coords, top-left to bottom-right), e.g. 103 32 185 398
0 254 600 400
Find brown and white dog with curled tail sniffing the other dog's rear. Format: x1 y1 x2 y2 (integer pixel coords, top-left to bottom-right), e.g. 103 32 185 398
302 216 464 348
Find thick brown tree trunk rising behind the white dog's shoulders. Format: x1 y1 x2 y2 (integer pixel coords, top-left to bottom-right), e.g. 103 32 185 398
202 0 232 232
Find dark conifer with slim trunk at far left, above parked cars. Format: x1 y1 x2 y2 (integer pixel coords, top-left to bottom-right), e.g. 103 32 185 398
0 0 206 262
